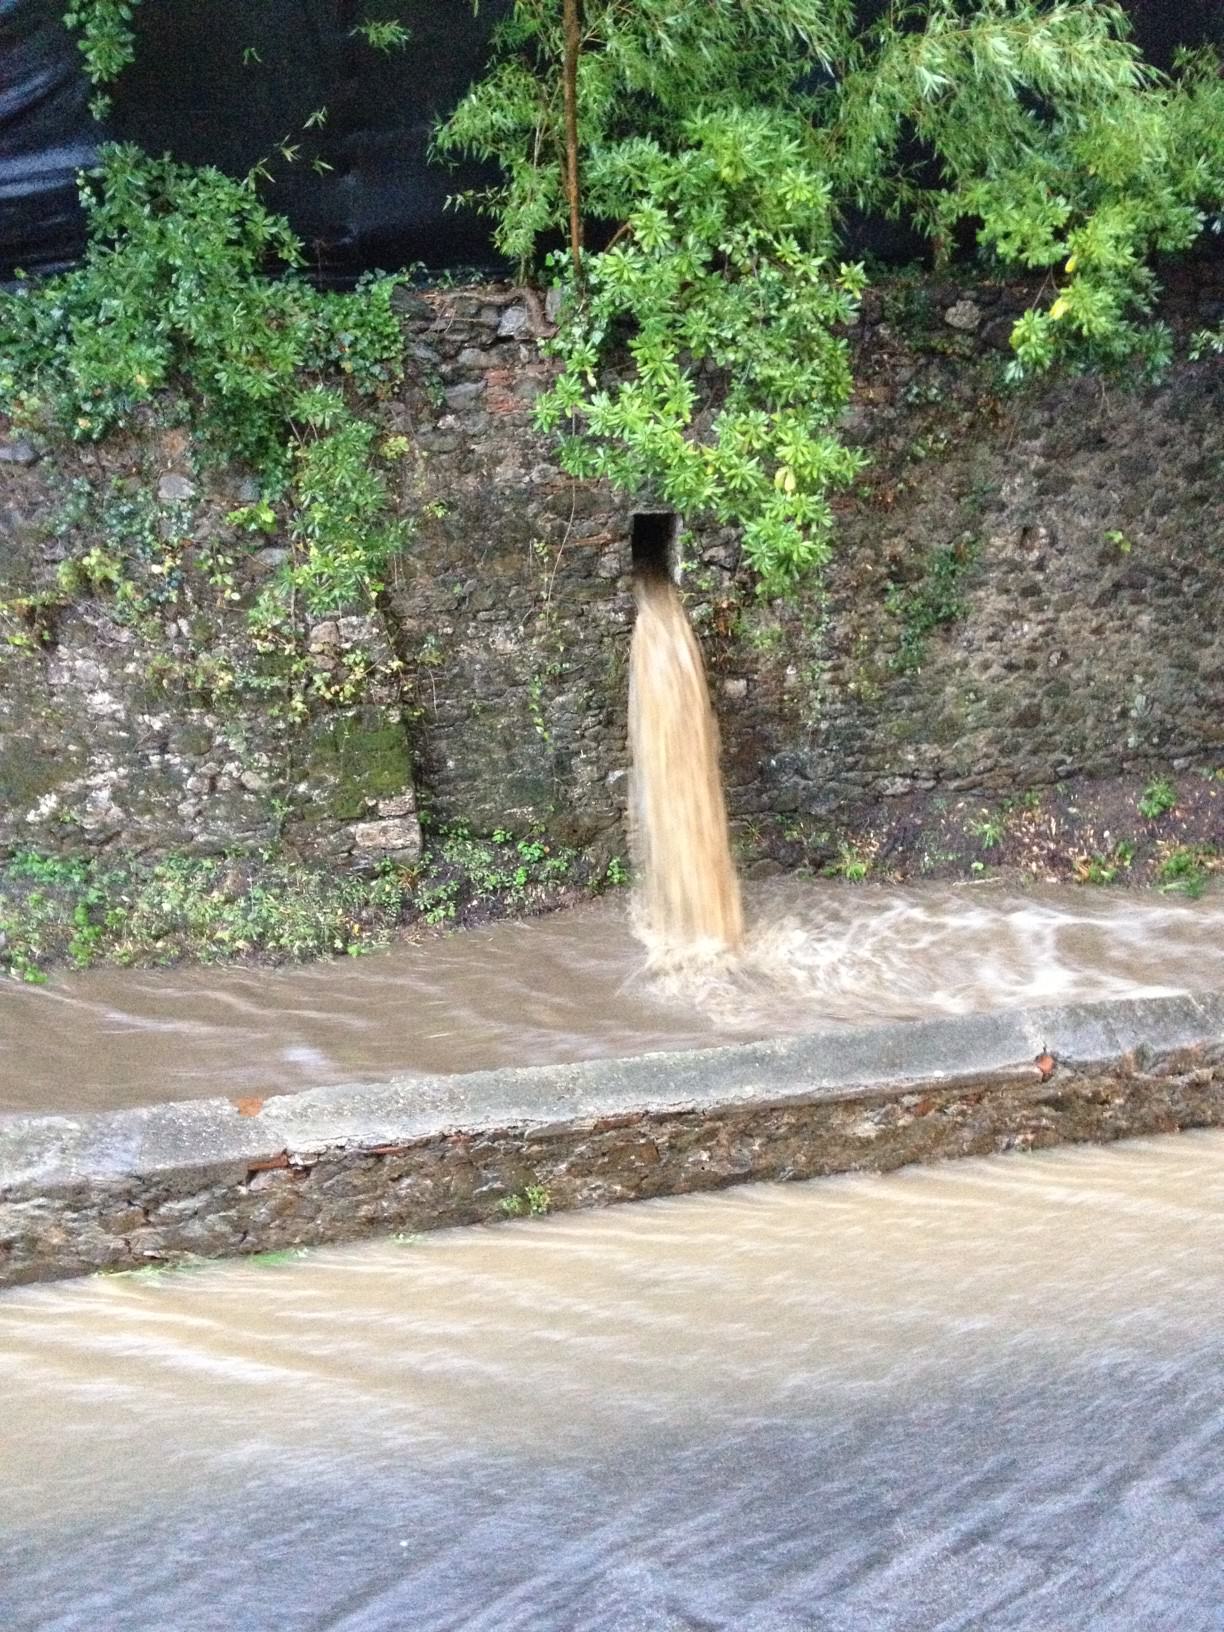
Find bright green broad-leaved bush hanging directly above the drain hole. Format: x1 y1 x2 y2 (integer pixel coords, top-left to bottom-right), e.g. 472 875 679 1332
537 109 863 591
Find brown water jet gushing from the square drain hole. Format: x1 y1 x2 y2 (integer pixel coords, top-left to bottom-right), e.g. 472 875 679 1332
628 573 744 966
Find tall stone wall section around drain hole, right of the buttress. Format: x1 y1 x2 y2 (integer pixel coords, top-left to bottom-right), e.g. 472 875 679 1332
392 272 1224 861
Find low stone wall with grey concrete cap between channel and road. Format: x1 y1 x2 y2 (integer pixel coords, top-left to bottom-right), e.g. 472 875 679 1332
0 994 1224 1286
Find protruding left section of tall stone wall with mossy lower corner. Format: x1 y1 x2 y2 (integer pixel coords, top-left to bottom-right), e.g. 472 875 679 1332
0 440 421 862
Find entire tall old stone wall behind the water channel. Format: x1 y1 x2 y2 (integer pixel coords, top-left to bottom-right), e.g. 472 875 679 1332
0 273 1224 862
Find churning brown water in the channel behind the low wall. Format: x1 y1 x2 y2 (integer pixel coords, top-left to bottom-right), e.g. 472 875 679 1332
0 881 1224 1116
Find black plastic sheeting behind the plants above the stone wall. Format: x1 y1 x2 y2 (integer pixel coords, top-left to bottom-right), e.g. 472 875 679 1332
0 0 1224 284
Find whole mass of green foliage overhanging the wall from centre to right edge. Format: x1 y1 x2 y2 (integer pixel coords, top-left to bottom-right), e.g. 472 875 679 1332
437 0 1224 589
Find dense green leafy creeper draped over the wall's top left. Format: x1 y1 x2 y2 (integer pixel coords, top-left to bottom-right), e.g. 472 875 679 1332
0 147 405 630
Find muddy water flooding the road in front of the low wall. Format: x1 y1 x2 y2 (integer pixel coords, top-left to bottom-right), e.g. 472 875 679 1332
0 1133 1224 1632
